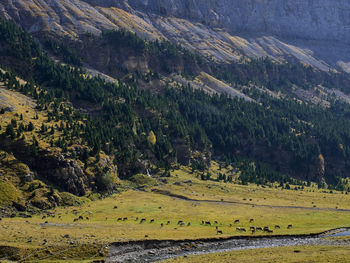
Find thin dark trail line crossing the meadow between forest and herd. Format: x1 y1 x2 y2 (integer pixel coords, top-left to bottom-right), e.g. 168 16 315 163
152 189 350 212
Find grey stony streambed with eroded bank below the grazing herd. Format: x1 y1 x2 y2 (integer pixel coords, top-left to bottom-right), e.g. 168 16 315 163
106 228 350 263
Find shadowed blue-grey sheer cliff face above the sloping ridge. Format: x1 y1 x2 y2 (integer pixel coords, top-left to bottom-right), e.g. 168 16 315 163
121 0 350 43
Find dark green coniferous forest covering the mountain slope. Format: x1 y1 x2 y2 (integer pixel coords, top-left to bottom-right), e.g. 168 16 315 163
0 19 350 190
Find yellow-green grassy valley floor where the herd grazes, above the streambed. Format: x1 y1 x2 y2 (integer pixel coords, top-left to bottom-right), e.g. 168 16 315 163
0 167 350 262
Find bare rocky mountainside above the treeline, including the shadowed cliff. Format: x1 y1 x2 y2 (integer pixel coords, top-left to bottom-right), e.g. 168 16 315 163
0 0 350 71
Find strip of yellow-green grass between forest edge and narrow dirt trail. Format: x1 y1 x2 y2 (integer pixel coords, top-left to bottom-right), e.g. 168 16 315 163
157 165 350 209
